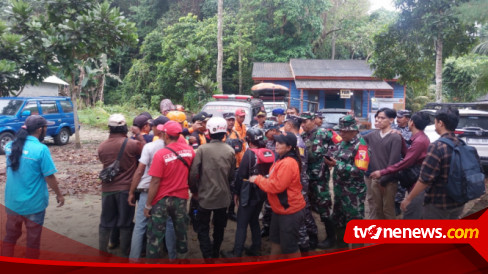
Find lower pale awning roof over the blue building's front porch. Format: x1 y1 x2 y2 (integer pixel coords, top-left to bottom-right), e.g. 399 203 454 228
295 80 393 90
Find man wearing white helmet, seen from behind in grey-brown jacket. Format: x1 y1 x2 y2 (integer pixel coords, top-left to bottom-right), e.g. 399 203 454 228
189 117 236 259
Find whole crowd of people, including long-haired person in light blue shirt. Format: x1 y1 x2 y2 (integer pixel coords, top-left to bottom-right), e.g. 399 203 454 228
2 100 480 261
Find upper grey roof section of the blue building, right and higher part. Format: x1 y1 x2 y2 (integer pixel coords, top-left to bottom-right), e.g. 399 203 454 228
290 59 373 77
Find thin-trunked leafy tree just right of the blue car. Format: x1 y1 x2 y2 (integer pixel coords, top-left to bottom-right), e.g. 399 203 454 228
43 0 137 148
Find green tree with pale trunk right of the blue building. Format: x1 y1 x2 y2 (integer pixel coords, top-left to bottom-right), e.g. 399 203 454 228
373 0 475 102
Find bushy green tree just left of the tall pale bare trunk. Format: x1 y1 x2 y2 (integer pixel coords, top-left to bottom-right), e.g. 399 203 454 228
122 14 217 107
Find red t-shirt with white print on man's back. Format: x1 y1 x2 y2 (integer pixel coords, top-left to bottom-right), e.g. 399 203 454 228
149 142 195 205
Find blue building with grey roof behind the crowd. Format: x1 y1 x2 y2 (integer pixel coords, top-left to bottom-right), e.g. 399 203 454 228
252 59 406 118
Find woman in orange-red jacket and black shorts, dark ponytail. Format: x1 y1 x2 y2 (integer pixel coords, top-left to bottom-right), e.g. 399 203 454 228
249 132 305 257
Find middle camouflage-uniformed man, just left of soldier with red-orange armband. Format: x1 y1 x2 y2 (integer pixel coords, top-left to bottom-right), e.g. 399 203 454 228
301 112 340 249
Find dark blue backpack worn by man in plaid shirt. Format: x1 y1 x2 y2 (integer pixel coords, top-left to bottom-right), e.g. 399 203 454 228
439 137 485 204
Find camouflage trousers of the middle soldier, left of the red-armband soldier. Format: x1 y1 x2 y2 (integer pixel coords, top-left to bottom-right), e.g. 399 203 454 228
309 176 332 222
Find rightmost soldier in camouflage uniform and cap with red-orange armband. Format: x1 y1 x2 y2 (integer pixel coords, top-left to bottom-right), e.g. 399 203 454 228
325 115 369 248
